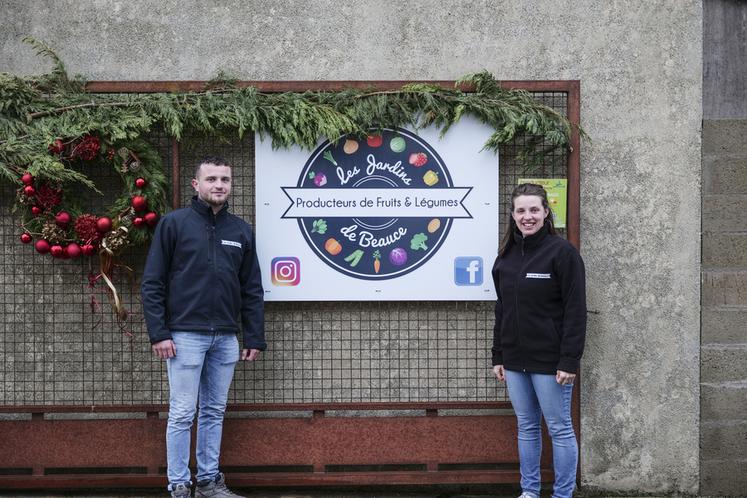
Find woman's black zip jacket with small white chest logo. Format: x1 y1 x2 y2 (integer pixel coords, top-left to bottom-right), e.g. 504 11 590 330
493 225 586 375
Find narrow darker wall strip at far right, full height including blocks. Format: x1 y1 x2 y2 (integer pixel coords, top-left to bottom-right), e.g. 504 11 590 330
700 0 747 496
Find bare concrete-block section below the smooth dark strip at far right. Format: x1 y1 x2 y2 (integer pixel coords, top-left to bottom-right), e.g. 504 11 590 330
700 119 747 495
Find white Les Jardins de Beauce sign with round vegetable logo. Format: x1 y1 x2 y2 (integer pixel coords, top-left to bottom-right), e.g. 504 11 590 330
255 118 499 301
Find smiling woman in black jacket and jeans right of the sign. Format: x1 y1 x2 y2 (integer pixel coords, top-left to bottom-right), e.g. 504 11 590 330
493 183 586 498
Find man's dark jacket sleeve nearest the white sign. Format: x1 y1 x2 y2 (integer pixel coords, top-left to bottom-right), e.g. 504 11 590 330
239 227 267 351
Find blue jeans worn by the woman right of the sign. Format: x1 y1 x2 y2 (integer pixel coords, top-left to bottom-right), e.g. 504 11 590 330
506 370 578 498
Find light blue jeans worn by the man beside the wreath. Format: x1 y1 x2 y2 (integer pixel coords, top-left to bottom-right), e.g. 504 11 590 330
166 331 239 486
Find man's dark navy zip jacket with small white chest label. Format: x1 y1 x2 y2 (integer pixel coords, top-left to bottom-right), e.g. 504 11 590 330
141 196 267 350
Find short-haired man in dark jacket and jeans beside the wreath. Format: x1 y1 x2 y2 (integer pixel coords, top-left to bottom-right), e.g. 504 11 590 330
142 157 266 498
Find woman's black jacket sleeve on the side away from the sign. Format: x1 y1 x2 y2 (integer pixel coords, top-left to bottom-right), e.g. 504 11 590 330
557 246 586 373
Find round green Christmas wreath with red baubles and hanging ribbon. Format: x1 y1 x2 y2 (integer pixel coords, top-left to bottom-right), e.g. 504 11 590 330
15 133 168 319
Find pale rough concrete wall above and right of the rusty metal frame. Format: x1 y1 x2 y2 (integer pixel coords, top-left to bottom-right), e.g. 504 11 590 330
0 0 702 492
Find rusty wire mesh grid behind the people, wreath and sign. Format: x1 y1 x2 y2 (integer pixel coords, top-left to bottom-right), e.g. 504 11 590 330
0 92 567 406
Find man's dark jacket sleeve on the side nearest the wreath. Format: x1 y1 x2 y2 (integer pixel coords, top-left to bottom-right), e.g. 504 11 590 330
140 218 175 344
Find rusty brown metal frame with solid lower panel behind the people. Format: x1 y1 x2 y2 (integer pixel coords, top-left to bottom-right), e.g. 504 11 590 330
0 81 580 489
